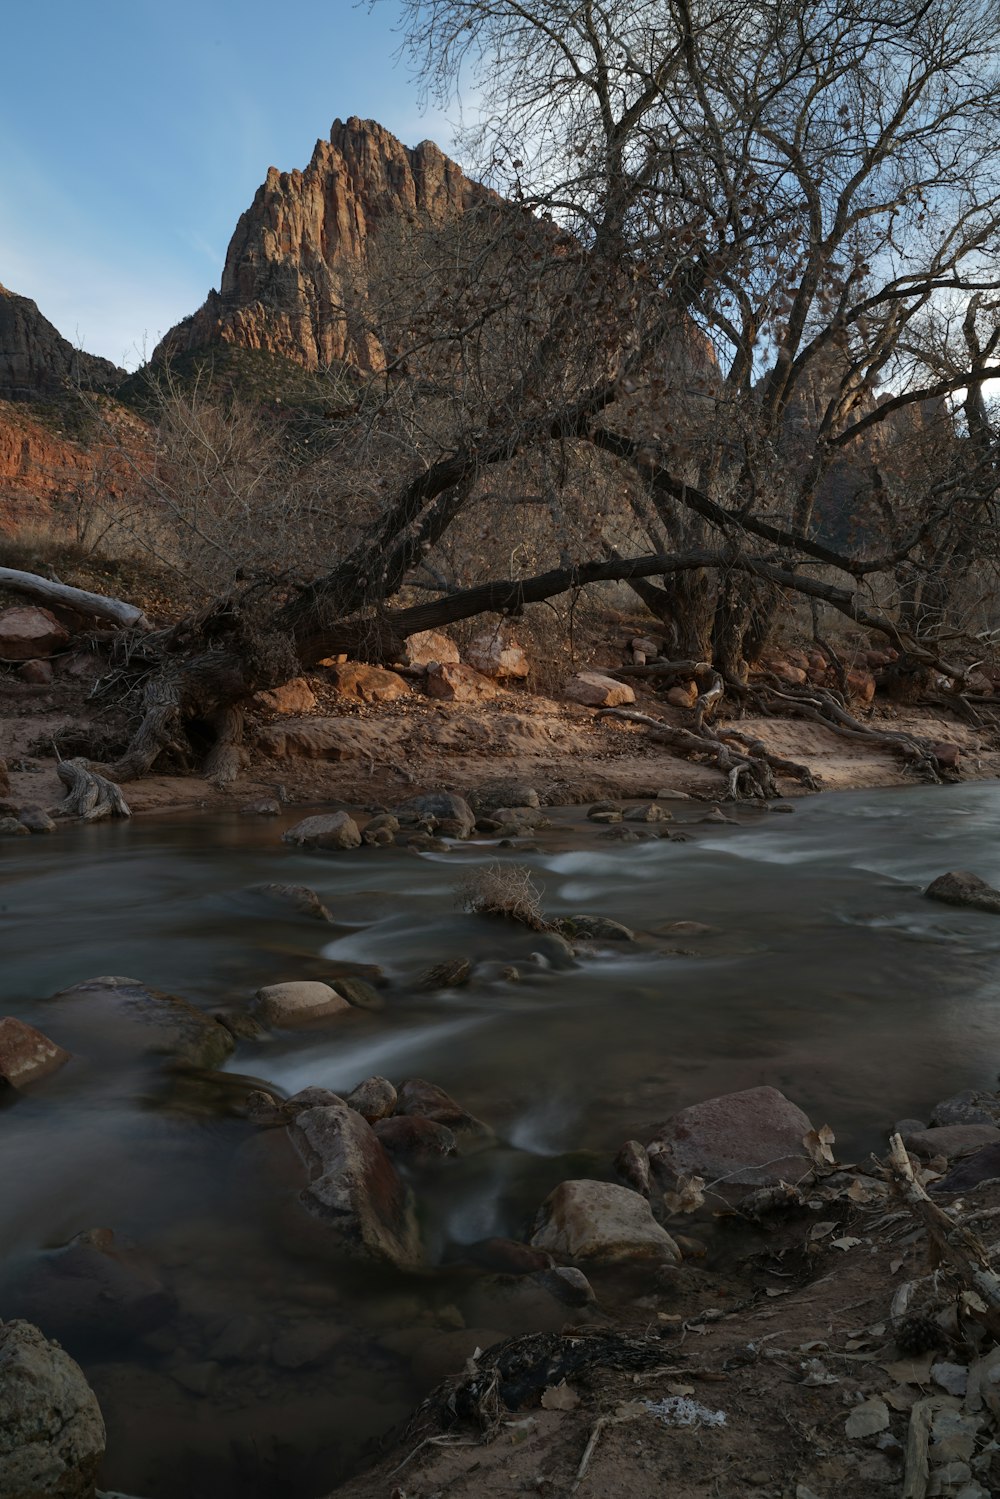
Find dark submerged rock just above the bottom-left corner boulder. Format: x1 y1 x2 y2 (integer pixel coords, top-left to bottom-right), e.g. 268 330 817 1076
4 1228 175 1351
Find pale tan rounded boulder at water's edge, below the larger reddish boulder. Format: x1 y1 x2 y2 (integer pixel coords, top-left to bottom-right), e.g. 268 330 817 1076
531 1181 681 1265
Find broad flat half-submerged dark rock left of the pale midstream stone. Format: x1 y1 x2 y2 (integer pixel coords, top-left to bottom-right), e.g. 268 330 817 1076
45 977 235 1069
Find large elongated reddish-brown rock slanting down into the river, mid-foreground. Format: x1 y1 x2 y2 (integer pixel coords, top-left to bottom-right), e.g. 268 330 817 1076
288 1102 421 1270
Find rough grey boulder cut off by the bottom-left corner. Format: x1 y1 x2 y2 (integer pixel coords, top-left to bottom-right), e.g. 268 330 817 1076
0 1321 105 1499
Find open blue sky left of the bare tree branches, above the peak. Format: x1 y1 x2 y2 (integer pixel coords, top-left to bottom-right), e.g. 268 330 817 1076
0 0 453 366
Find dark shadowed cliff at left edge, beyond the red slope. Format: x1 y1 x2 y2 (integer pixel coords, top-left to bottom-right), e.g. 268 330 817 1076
0 286 124 400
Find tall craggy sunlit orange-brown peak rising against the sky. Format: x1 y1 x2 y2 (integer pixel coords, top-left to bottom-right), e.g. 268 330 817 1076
153 118 486 369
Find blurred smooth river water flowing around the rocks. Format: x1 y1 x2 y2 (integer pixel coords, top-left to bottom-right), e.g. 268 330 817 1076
0 784 1000 1499
